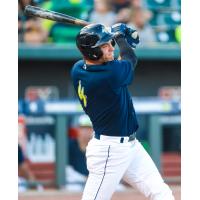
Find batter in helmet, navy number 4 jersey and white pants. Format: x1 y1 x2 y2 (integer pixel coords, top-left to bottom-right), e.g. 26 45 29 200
71 23 174 200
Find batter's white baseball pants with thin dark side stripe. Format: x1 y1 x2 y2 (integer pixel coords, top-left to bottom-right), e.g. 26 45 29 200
82 135 174 200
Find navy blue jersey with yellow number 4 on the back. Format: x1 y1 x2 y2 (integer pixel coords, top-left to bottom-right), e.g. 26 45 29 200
71 60 138 136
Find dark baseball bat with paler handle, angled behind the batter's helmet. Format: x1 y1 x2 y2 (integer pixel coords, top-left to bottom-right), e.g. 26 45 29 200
24 5 90 26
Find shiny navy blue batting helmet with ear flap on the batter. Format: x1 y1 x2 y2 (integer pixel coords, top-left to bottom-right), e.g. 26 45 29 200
76 24 114 60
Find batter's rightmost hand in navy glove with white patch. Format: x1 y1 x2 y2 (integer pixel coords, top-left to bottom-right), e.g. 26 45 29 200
125 27 140 49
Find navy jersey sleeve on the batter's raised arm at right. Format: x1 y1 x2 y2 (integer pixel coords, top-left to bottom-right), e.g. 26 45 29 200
111 60 133 87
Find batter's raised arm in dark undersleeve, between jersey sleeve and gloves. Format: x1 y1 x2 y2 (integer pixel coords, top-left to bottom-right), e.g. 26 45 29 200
116 36 137 68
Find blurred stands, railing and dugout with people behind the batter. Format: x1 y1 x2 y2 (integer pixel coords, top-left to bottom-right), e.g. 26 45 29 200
18 0 181 197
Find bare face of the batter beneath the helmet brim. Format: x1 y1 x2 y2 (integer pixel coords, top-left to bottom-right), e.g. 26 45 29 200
101 42 115 62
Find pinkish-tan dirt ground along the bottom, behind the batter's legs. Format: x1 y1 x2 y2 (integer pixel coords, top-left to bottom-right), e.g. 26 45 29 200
18 186 181 200
